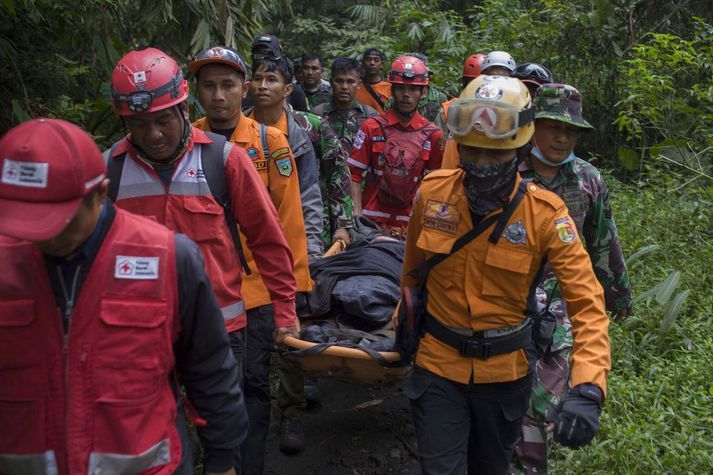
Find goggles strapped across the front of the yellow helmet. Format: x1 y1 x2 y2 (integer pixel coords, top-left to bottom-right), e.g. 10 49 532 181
446 99 535 139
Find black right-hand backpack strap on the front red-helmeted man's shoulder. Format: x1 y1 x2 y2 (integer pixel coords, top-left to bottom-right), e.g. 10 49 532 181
201 132 252 275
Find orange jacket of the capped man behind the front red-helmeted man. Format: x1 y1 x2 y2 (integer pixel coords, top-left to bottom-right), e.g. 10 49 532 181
193 115 313 309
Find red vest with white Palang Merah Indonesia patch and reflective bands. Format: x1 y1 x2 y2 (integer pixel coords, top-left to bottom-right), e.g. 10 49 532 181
0 210 181 474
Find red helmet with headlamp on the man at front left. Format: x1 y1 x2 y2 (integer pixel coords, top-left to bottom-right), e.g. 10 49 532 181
111 48 188 115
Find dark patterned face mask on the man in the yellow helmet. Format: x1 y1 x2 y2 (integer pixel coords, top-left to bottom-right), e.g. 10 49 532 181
460 157 519 216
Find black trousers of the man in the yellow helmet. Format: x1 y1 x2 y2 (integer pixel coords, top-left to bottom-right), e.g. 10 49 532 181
404 366 531 475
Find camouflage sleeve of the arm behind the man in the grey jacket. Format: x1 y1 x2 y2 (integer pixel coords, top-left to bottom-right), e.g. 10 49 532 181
293 111 354 248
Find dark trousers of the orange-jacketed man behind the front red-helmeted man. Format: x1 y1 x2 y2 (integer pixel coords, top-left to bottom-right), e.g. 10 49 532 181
236 304 275 475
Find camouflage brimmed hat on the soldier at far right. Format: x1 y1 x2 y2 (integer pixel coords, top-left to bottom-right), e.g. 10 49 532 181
535 84 594 129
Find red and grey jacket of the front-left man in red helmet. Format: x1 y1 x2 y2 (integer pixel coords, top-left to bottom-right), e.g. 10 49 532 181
110 139 246 332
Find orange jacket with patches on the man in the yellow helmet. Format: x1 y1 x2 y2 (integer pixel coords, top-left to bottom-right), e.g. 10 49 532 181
402 165 610 393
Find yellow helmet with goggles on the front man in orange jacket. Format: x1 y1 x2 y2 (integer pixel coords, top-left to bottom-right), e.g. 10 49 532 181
446 75 535 149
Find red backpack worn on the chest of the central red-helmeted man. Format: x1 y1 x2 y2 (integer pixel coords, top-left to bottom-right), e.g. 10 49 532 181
375 116 439 209
